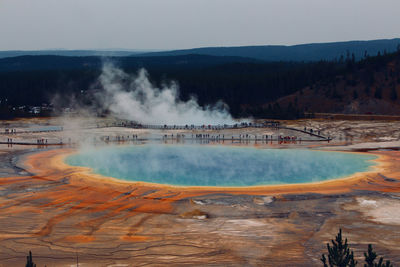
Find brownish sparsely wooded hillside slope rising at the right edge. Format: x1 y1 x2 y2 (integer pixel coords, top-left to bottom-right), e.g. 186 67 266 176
264 52 400 115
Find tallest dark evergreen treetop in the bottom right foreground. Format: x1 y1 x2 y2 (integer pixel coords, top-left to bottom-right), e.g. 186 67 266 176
321 229 357 267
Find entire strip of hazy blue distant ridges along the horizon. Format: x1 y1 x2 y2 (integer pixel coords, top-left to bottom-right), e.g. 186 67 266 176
0 38 400 62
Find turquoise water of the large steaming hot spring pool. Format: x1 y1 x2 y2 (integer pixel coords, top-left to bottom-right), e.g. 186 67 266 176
66 145 376 186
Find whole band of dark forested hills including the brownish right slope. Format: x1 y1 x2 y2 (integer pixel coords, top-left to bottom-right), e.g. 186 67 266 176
0 50 400 119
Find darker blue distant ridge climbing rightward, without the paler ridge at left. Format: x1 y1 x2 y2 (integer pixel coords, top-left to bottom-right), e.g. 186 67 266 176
135 38 400 61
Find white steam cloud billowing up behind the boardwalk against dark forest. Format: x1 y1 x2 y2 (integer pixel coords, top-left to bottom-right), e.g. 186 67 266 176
99 63 235 125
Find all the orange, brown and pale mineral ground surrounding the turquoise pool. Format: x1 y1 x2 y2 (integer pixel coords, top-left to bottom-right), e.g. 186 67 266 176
0 118 400 267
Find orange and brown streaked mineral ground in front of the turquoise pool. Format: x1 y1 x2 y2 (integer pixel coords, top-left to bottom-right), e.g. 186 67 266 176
0 149 400 266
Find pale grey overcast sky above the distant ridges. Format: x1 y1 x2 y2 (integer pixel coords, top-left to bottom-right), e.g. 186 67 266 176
0 0 400 50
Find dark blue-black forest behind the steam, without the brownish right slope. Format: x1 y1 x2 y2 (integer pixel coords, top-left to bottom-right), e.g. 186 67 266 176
0 49 398 119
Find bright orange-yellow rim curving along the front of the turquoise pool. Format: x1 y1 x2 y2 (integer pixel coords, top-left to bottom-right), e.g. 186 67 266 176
25 149 400 200
